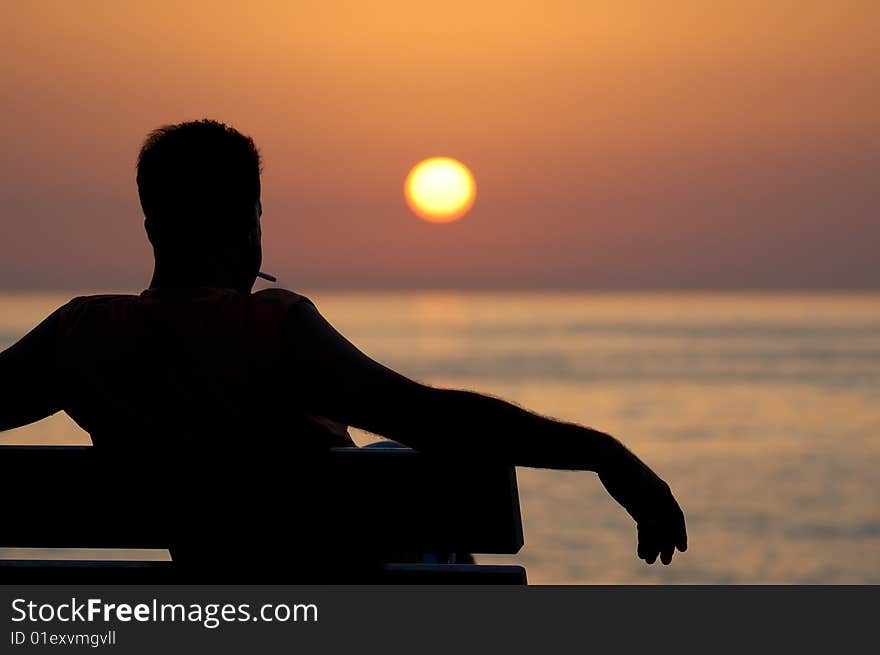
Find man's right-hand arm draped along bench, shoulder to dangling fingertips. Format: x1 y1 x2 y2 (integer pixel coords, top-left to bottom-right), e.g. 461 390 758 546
287 303 687 564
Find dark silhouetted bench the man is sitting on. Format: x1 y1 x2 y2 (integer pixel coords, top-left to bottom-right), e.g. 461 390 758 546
0 446 526 584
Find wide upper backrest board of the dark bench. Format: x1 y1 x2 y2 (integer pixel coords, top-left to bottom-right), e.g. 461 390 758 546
0 446 523 560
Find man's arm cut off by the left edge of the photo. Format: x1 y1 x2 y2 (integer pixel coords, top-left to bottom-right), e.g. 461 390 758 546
0 308 63 431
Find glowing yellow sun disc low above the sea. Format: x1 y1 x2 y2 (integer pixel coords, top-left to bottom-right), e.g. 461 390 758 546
404 157 477 223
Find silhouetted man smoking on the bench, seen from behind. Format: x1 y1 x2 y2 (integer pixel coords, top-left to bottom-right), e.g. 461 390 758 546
0 120 687 564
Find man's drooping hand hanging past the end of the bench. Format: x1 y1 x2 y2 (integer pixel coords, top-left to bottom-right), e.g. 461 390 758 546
599 446 687 564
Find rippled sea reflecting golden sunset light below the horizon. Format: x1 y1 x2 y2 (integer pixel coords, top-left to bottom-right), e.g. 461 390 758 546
0 292 880 583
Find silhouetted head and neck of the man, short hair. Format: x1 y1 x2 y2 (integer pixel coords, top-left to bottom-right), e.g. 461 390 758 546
137 119 262 289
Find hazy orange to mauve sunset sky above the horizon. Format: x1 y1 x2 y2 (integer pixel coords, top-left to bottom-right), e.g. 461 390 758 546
0 0 880 289
